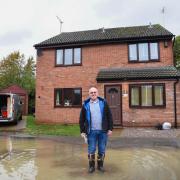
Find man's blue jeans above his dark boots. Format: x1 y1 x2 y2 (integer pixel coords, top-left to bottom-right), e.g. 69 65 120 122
87 130 108 155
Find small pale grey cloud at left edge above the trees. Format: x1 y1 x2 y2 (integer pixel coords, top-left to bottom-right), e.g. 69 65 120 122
0 30 32 46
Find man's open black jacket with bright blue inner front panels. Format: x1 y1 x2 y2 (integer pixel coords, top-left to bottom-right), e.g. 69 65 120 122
79 97 113 134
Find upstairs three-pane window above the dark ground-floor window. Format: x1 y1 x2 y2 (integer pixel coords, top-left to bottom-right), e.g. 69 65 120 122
56 48 82 66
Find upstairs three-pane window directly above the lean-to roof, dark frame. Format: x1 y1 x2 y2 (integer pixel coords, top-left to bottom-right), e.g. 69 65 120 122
128 42 159 62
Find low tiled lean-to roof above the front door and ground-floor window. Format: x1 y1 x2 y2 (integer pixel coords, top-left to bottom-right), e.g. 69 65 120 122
96 66 180 81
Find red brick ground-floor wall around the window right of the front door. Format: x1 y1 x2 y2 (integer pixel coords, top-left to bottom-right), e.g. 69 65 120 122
122 81 174 126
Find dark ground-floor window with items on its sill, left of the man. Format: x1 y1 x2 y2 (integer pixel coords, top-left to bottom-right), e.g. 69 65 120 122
54 88 82 107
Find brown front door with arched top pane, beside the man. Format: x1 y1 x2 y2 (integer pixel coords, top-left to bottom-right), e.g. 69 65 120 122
105 85 122 126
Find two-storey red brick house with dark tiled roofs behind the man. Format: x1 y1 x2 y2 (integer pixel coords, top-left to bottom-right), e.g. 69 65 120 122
34 24 180 127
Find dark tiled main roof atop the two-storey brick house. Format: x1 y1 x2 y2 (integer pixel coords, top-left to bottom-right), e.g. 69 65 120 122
34 24 174 49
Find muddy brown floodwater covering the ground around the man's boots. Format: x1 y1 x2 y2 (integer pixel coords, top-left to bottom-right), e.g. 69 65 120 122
0 136 180 180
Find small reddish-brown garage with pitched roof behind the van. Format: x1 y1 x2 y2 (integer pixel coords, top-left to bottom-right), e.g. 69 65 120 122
0 85 28 115
